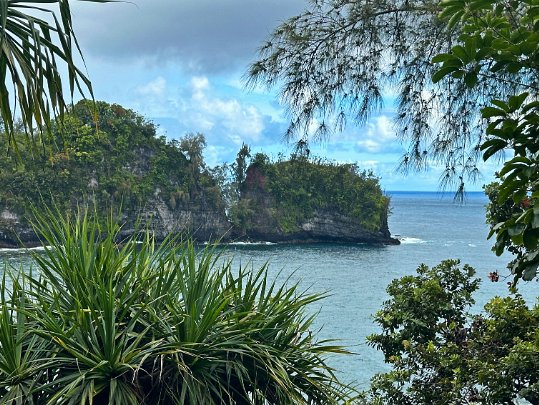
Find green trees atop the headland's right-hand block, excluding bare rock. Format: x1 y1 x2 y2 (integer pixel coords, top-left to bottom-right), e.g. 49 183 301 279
232 148 389 233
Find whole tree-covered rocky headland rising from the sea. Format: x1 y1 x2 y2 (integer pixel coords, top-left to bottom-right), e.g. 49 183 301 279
0 101 399 247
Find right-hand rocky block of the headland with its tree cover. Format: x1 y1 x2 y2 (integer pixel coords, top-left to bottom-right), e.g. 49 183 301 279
231 148 397 243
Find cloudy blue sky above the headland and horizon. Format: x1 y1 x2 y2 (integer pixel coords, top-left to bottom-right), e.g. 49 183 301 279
71 0 498 191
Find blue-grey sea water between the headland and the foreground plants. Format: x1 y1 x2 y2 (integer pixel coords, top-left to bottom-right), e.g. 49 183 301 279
0 191 539 389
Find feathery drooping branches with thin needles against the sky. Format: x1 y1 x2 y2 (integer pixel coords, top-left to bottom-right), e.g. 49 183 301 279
248 0 535 187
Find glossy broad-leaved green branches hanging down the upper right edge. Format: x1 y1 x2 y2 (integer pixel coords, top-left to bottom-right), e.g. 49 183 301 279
433 0 539 283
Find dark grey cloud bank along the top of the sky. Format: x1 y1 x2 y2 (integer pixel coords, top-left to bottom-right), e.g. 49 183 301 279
71 0 305 74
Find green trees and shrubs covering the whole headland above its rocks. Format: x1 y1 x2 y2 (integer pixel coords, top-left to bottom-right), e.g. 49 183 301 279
0 101 389 243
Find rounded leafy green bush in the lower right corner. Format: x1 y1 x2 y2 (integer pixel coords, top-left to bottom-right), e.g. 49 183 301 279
366 261 539 405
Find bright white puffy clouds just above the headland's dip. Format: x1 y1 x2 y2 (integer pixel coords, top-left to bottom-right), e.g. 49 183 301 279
126 75 273 150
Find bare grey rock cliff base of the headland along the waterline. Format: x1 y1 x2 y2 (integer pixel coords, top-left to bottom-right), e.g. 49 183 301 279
0 204 400 249
